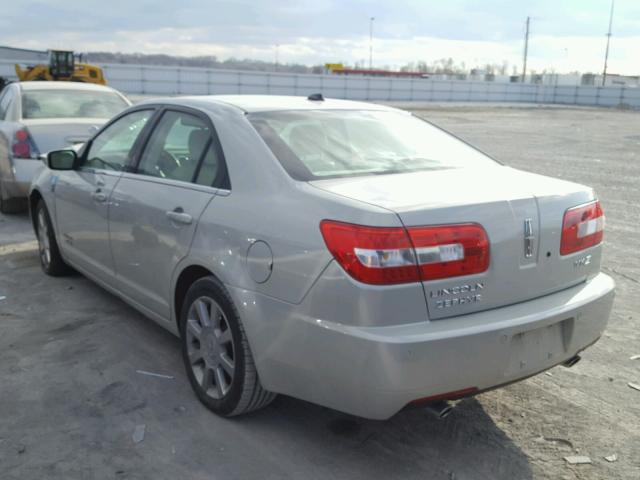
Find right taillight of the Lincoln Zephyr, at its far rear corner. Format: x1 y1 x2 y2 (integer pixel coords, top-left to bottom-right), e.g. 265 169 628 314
560 200 604 255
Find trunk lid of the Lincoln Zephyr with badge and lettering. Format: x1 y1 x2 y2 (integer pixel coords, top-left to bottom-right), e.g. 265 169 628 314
311 165 601 319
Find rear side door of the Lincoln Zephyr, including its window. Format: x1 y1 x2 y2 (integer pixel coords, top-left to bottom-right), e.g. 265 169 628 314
109 109 225 319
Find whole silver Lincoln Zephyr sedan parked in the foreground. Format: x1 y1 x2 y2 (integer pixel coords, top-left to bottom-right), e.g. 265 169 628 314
30 95 614 419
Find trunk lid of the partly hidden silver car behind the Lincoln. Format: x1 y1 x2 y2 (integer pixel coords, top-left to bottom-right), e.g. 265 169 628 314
22 118 107 153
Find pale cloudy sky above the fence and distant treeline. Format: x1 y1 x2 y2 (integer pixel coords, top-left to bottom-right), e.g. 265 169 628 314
0 0 640 75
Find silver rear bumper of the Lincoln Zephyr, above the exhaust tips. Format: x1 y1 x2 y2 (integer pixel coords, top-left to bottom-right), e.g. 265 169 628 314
230 273 615 419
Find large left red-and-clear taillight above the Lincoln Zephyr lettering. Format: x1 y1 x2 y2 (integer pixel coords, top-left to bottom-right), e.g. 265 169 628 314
320 220 489 285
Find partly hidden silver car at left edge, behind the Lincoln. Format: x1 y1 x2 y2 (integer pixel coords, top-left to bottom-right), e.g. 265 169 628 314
0 82 131 213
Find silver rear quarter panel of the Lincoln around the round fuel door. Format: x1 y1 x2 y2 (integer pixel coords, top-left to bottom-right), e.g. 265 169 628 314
189 172 404 303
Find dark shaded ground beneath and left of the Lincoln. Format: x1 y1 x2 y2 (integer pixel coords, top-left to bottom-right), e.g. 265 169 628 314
0 238 532 480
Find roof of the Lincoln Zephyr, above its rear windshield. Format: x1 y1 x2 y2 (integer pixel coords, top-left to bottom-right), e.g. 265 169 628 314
141 95 396 113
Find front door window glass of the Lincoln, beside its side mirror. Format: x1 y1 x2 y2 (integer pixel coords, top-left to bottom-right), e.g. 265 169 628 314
82 110 153 171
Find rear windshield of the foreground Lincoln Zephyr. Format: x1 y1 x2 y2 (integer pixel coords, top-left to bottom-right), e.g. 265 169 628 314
248 110 495 181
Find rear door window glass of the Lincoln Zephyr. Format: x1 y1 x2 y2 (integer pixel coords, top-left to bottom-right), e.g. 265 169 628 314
138 110 213 185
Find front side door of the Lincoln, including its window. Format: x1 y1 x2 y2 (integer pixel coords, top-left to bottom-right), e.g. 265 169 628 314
52 109 154 282
